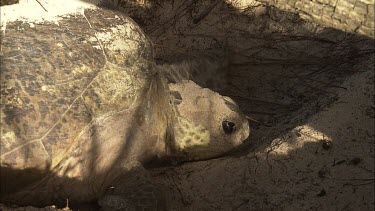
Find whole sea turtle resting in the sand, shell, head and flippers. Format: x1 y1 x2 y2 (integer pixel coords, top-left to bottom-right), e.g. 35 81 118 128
0 4 249 210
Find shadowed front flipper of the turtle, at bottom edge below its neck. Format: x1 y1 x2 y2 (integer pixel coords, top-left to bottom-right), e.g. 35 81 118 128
99 166 167 211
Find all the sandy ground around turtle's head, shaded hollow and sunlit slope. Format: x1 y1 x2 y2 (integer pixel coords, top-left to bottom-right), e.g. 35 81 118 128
0 0 375 210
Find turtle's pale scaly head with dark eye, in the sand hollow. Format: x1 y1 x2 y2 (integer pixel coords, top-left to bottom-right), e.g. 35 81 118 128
169 81 250 160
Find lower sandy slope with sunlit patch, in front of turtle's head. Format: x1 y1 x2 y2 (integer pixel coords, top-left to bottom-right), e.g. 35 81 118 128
153 55 374 210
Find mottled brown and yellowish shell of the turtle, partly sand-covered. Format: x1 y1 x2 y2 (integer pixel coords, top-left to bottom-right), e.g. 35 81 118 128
1 10 152 172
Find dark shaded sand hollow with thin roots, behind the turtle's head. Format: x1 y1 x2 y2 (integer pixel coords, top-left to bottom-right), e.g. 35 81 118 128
106 1 375 154
